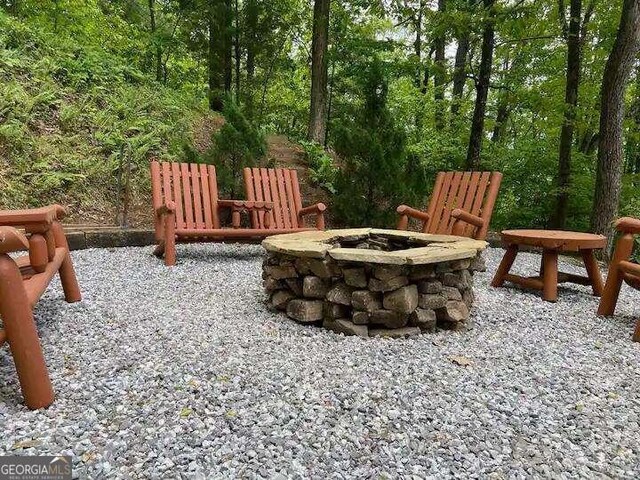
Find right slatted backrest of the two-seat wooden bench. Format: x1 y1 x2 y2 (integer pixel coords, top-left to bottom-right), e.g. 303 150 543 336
243 168 302 230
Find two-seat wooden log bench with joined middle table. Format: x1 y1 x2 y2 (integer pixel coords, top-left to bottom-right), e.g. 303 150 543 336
151 161 326 265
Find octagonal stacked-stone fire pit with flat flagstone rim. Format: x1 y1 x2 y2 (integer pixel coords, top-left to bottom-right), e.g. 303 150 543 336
262 228 487 337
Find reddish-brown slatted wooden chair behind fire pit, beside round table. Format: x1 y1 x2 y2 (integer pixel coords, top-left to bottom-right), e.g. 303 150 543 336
397 172 502 240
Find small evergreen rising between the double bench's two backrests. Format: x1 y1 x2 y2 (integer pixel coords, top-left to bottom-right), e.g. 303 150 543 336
204 97 267 198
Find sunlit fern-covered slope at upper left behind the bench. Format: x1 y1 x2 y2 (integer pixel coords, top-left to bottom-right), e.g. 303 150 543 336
0 8 205 218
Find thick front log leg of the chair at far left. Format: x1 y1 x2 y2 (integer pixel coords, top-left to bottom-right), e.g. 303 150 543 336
0 255 54 409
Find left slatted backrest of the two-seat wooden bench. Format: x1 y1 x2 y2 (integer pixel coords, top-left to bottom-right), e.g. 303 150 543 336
151 161 220 232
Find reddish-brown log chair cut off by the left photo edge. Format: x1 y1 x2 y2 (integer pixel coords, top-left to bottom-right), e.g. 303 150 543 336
0 205 81 409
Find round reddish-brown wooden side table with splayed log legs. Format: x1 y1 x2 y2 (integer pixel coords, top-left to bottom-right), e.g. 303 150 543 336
491 230 607 302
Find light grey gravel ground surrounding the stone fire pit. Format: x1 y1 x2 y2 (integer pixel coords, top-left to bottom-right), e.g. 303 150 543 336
0 245 640 478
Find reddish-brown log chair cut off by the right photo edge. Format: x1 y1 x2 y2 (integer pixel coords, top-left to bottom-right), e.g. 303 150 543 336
598 217 640 342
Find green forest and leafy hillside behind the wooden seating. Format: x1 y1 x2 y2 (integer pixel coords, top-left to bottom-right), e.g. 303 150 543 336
0 0 640 244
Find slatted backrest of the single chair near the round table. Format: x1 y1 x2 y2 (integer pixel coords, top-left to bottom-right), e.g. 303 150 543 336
423 172 502 238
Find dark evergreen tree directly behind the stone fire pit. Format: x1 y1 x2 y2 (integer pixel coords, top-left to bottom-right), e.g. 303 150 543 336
333 59 406 227
